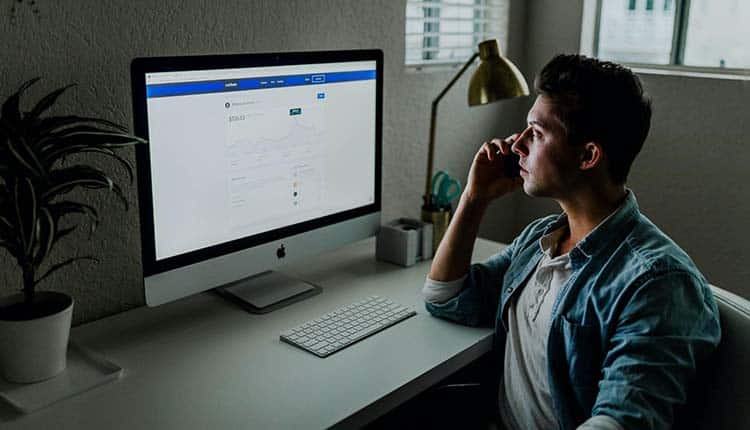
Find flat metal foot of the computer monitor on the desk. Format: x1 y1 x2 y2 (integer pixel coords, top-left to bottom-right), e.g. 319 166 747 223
214 271 321 314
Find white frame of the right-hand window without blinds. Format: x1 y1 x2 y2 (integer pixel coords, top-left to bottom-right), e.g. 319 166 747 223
581 0 750 80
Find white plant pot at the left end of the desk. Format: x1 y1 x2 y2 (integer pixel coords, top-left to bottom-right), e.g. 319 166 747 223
0 291 73 383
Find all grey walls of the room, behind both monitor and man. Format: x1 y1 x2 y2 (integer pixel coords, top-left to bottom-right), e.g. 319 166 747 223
0 0 750 323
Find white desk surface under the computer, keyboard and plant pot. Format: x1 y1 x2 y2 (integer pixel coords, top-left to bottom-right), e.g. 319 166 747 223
0 239 502 430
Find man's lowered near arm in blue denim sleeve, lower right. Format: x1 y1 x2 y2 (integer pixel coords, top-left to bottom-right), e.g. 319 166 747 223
592 272 721 429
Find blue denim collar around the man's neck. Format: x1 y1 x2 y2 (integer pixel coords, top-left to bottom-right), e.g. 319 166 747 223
540 189 640 268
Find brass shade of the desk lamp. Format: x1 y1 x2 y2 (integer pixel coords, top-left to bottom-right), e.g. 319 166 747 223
469 39 529 106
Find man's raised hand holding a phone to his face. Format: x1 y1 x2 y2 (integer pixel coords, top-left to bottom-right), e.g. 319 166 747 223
465 133 523 203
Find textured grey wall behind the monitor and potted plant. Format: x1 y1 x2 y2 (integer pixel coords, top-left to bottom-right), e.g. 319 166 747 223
0 0 524 323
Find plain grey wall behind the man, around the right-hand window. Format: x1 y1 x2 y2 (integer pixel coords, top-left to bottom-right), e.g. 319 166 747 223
515 0 750 297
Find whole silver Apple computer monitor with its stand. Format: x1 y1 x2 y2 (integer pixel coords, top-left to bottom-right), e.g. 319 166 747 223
131 50 383 312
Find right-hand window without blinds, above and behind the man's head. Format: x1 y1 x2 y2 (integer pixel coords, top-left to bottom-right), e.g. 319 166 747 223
584 0 750 71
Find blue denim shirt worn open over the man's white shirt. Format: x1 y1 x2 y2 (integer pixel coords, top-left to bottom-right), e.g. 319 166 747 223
426 191 721 430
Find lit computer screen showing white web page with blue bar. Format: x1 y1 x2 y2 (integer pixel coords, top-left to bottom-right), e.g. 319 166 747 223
145 61 376 260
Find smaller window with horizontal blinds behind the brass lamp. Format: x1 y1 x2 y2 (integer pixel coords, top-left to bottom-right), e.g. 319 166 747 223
405 0 509 67
